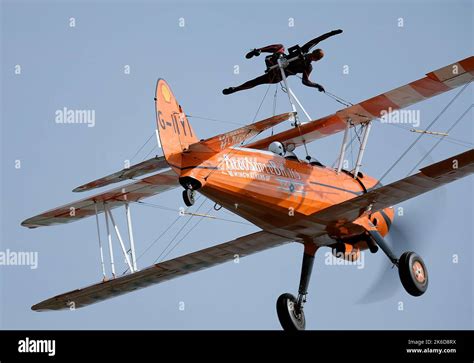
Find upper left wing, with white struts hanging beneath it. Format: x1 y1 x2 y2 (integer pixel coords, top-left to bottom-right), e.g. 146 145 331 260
21 169 179 228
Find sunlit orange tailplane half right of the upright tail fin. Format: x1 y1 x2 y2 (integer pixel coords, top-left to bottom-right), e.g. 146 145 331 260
189 112 294 152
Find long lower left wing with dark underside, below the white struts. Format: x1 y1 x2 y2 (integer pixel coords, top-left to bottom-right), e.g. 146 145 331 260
31 231 290 311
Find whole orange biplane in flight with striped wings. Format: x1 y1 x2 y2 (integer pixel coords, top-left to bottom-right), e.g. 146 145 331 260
22 57 474 330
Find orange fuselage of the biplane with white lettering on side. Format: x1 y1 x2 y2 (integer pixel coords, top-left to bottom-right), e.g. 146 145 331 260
174 148 394 245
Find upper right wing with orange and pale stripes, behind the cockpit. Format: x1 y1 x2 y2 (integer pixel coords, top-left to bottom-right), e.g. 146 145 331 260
247 56 474 149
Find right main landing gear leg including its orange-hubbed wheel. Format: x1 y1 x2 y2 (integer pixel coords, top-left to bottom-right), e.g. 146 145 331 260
371 233 428 296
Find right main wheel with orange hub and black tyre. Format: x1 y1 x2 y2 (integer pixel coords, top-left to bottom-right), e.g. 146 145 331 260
398 252 428 296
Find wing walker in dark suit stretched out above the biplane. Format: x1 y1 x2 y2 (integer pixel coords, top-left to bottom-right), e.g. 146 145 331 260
222 29 342 95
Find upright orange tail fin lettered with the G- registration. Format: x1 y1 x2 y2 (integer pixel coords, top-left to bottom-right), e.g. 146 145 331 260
155 79 199 174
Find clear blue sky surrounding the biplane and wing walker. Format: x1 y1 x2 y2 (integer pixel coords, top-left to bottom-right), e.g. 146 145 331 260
0 1 474 329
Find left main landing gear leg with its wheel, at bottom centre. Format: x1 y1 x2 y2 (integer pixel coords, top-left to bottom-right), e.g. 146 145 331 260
276 242 317 331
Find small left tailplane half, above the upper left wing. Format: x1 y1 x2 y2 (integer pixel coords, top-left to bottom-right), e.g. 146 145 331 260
73 156 169 192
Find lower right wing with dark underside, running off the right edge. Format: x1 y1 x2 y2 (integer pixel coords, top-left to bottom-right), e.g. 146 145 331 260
311 149 474 225
